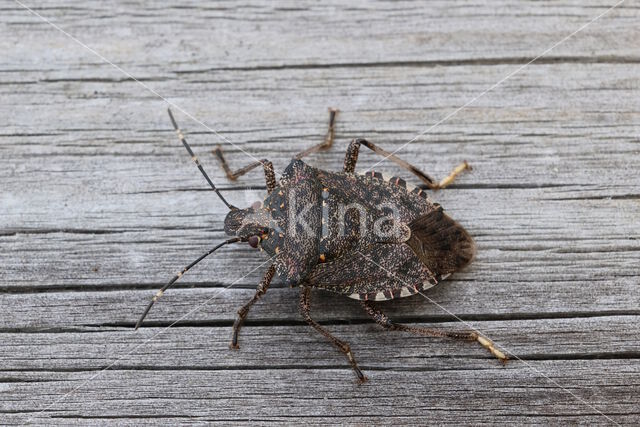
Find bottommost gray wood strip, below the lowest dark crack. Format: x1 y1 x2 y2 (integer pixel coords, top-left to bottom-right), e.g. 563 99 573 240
2 360 639 425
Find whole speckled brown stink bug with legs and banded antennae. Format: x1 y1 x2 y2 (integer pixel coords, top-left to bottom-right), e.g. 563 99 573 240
136 110 507 382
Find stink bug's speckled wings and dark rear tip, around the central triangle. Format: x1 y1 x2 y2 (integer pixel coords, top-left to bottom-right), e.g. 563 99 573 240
305 170 475 300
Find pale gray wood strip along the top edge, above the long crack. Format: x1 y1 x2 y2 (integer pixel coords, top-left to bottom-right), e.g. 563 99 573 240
3 1 638 72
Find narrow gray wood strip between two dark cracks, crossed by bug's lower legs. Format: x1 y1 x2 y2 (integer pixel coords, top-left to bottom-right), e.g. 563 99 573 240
0 279 640 331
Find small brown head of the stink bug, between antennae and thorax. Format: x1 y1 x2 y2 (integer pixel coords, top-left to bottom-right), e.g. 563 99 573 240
224 202 270 248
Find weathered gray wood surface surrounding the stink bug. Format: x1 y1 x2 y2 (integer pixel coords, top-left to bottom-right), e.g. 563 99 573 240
0 0 640 425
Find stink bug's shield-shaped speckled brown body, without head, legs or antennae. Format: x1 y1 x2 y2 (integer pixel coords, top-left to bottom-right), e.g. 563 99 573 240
254 160 475 300
